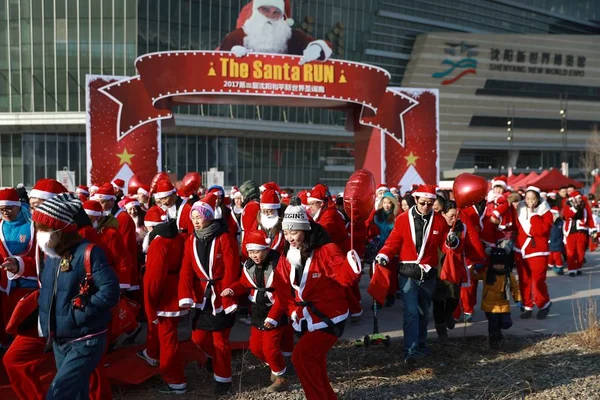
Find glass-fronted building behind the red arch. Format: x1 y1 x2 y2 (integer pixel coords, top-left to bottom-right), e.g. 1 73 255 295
0 0 600 187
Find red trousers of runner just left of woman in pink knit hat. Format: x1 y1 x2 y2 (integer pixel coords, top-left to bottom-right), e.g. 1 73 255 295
146 317 185 385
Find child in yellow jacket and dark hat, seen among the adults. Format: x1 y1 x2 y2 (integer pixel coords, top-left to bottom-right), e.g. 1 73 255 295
481 248 521 349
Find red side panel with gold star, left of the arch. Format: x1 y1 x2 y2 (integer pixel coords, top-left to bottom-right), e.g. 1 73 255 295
86 75 161 187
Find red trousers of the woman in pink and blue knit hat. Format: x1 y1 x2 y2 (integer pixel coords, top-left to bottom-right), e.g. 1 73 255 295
192 328 231 383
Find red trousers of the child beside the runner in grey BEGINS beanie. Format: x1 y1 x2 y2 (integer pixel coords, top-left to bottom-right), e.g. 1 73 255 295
250 326 285 376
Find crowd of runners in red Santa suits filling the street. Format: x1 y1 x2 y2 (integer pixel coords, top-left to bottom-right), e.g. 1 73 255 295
0 175 597 399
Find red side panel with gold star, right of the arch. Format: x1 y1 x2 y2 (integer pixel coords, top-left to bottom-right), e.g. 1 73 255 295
354 88 440 194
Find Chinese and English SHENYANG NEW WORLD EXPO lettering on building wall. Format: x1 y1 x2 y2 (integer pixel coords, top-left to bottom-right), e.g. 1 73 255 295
490 48 586 77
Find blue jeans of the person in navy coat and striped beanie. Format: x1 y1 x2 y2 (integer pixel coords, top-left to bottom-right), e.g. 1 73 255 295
46 333 106 400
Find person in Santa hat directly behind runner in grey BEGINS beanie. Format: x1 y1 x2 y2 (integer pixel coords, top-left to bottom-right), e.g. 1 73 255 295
307 183 363 323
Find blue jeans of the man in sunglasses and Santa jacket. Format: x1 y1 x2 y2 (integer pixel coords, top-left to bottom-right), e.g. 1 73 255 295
398 275 436 358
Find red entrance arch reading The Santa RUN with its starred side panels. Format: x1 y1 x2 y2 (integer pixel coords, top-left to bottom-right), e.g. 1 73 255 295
88 51 439 190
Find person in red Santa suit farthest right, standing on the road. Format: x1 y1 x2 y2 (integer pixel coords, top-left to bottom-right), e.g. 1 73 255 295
563 190 596 277
